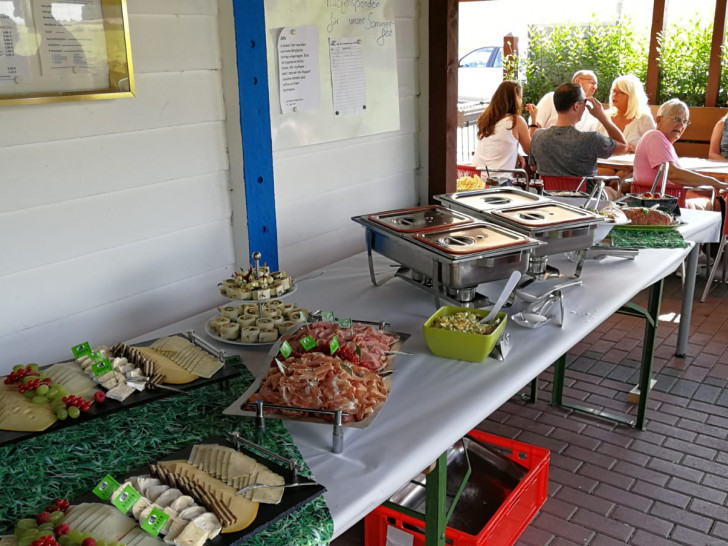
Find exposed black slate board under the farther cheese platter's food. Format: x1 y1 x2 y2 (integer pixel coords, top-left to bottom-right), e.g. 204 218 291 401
0 333 240 447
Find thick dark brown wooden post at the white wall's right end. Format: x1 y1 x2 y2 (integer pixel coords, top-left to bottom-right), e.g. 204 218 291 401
428 0 458 202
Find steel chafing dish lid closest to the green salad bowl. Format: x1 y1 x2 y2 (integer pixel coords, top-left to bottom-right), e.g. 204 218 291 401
404 222 543 260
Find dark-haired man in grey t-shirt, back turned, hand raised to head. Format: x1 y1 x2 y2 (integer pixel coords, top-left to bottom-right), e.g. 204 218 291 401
528 83 627 199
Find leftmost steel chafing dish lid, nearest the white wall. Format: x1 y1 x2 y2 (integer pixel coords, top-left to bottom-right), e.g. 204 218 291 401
353 205 474 234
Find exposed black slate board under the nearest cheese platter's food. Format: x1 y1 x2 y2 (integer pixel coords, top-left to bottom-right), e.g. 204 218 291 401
72 436 326 546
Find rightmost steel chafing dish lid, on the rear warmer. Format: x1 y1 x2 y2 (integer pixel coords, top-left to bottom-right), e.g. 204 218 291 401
488 201 602 231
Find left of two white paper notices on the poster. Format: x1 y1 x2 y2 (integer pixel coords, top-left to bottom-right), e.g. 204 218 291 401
278 27 321 114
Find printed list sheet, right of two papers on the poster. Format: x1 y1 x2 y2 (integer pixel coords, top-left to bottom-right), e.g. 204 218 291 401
329 38 367 116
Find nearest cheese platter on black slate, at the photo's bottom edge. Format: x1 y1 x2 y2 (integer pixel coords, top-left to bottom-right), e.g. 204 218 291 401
0 433 325 546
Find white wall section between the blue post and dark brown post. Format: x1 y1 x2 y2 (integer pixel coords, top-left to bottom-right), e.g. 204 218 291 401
272 0 420 275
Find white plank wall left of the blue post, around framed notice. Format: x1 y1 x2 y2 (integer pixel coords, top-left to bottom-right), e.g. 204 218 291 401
0 0 234 373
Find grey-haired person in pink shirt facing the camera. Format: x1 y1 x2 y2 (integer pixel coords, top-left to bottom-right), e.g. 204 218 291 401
634 99 728 209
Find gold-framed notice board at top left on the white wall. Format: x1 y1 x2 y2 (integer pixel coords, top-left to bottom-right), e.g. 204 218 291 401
0 0 134 105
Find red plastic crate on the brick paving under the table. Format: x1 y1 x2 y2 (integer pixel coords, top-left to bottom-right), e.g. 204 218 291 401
364 430 549 546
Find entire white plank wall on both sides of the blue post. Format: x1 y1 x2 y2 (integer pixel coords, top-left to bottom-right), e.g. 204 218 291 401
0 0 419 374
